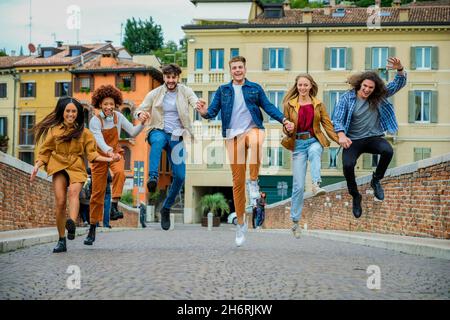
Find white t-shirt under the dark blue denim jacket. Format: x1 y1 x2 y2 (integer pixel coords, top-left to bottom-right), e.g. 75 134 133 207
226 84 256 139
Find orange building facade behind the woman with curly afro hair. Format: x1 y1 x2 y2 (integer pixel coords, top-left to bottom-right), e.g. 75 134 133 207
71 49 171 205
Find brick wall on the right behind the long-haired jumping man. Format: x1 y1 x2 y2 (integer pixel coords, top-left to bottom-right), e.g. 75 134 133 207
264 153 450 239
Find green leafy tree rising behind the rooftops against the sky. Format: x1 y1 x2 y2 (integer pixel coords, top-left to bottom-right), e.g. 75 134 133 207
122 17 164 54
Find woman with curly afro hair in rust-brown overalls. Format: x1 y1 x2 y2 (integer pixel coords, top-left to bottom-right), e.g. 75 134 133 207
84 85 148 245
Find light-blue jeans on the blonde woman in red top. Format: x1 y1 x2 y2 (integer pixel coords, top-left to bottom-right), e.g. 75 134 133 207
291 137 323 222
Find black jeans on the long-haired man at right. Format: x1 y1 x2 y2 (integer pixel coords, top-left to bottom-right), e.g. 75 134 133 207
342 137 394 197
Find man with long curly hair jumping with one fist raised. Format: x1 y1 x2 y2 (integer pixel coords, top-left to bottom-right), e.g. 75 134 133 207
333 57 406 218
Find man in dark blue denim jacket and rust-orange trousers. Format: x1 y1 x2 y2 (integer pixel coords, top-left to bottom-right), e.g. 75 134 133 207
197 56 294 246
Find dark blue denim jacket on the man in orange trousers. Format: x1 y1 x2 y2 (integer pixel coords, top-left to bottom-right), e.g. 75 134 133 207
203 79 284 138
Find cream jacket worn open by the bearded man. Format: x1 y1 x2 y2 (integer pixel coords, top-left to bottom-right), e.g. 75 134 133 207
134 83 198 136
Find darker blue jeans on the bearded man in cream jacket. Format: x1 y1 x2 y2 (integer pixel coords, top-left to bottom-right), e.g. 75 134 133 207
147 130 186 209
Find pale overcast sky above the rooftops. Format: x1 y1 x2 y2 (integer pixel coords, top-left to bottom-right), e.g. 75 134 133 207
0 0 195 54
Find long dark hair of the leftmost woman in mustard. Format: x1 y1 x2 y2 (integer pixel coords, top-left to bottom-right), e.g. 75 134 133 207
32 97 84 142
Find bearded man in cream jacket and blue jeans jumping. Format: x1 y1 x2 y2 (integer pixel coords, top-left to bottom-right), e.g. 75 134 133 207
134 64 198 230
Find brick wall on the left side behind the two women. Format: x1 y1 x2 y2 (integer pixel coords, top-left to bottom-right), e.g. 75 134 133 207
0 152 139 231
